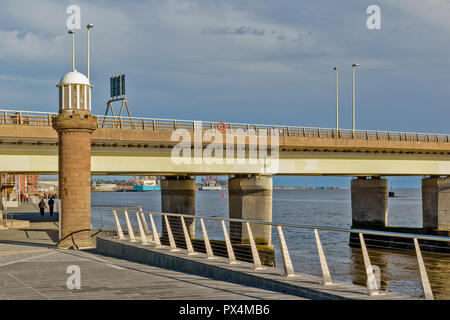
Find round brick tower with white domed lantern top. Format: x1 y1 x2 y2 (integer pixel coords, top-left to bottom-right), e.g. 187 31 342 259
52 70 97 249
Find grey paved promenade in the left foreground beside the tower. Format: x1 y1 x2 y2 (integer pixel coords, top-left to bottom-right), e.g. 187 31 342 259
0 213 301 300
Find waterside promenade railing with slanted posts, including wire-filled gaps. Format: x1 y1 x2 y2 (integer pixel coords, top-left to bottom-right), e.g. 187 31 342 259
112 208 450 300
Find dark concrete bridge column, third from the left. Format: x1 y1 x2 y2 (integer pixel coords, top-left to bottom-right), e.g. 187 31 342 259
351 177 388 228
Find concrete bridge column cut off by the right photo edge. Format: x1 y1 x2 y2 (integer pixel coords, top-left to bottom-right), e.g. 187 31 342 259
422 177 450 232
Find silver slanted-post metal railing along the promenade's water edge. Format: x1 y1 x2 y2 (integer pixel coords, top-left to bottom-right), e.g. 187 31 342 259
112 208 450 300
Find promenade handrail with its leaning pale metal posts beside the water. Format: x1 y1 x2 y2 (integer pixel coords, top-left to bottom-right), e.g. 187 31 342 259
112 207 450 300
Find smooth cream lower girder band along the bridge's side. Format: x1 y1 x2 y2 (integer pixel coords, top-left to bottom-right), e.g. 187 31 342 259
0 147 450 176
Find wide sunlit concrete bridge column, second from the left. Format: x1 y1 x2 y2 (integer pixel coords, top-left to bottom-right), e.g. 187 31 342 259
228 176 272 245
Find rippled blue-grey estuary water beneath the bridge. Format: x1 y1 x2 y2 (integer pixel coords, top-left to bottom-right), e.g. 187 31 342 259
92 189 450 299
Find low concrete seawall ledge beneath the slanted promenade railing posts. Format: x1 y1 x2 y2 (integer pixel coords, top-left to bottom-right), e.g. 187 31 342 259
97 237 413 300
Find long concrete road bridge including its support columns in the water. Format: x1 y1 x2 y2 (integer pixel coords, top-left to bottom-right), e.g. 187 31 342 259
0 110 450 248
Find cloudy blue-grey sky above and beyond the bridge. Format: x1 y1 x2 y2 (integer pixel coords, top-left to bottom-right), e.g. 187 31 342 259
0 0 450 186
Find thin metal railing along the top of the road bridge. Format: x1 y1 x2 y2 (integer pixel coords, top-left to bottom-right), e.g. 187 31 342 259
0 110 450 143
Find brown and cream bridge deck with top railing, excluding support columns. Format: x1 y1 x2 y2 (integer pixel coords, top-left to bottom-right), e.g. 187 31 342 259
0 111 450 176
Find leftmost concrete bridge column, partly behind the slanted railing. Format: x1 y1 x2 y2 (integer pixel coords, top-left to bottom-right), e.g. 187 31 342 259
161 176 195 242
